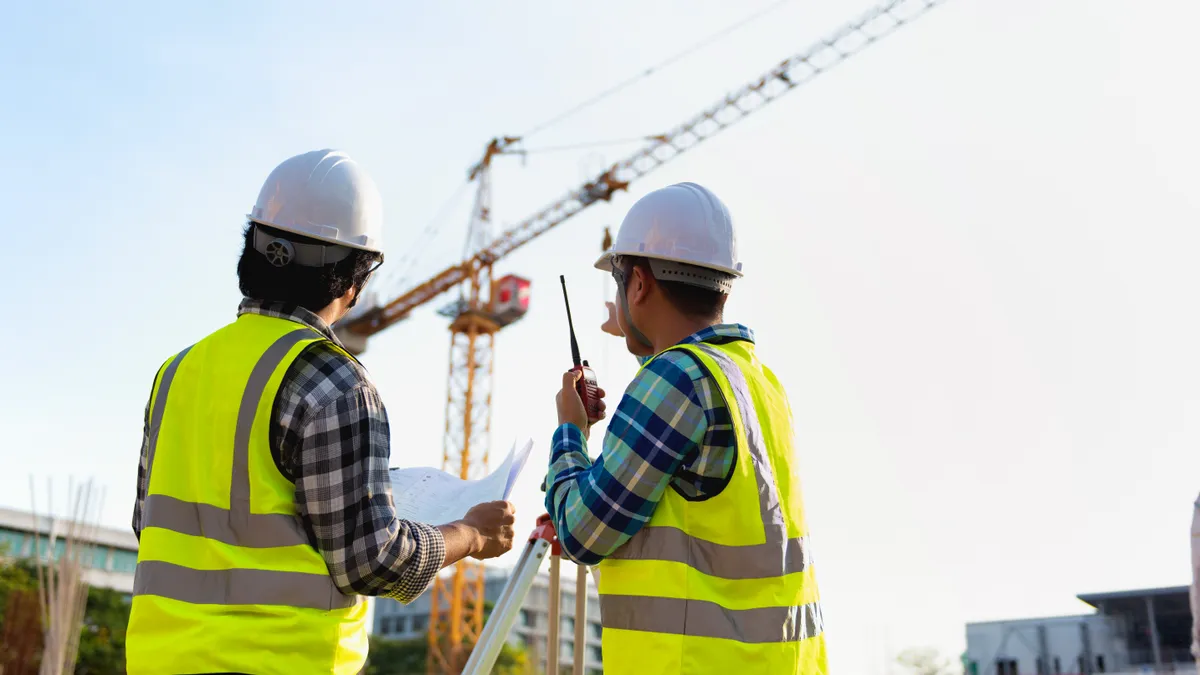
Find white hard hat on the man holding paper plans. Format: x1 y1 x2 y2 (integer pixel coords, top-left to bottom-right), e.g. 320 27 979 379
248 150 383 257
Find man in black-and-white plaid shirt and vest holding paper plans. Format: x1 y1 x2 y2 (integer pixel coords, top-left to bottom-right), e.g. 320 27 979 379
126 150 514 675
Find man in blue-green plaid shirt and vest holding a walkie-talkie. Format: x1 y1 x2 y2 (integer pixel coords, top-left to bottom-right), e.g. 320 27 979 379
546 183 827 675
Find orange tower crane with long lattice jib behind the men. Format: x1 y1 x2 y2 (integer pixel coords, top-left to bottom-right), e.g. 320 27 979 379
335 0 946 674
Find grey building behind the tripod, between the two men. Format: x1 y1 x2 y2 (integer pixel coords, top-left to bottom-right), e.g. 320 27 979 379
373 566 602 675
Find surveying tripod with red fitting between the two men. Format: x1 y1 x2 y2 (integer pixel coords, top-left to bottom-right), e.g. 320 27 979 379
462 515 588 675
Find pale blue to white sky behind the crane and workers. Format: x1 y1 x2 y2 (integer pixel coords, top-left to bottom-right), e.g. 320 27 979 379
0 0 1200 674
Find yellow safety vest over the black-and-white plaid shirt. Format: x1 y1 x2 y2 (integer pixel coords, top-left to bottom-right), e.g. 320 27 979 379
126 313 367 675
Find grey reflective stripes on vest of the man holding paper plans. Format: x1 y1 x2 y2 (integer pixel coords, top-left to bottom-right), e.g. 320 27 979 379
133 328 360 610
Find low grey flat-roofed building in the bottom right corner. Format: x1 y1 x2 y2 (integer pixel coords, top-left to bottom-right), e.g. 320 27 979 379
967 586 1196 675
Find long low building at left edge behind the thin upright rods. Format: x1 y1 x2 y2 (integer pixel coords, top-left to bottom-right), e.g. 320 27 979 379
0 507 138 597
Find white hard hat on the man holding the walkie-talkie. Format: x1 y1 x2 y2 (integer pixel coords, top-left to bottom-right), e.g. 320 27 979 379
595 183 742 279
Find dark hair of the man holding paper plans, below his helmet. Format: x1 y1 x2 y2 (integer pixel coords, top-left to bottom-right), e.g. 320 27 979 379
238 222 379 312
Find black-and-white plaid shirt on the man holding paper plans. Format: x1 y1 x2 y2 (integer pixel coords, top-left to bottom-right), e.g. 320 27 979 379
133 299 445 603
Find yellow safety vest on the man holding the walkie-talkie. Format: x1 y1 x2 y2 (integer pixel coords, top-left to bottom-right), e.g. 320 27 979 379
599 341 828 675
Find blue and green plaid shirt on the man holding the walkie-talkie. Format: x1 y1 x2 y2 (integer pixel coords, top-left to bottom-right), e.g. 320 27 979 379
546 324 754 565
